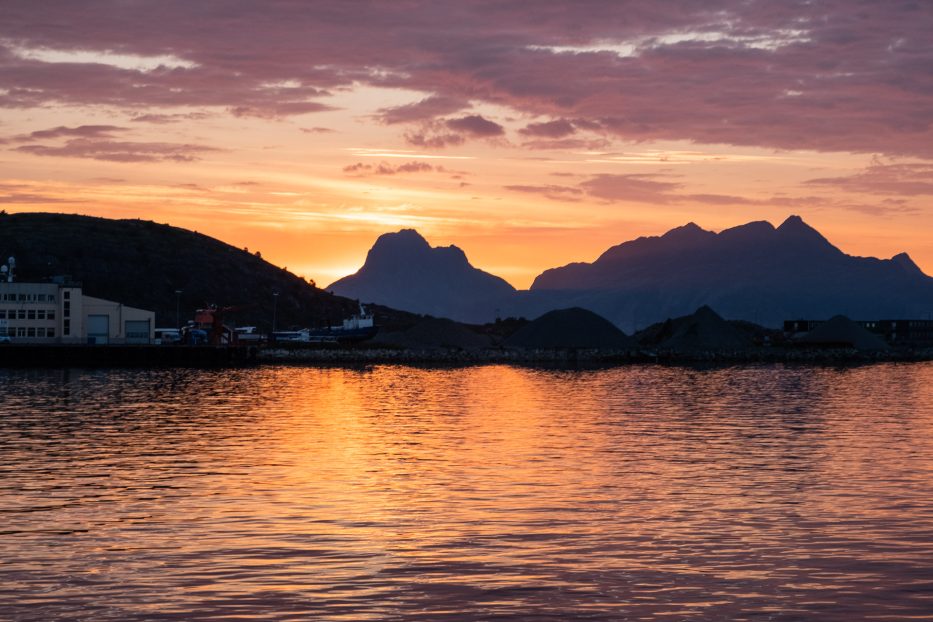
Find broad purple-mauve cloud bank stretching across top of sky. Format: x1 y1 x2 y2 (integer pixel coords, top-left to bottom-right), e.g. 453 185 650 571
0 0 933 158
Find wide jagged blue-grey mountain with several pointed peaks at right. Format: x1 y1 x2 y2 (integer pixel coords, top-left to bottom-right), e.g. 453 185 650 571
524 216 933 329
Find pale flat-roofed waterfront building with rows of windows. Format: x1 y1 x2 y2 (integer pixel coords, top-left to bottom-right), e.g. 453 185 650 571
0 281 155 344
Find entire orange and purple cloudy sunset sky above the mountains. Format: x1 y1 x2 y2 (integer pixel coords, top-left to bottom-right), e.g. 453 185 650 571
0 0 933 288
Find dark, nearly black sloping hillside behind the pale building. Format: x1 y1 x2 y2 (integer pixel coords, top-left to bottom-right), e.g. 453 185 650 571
0 214 410 330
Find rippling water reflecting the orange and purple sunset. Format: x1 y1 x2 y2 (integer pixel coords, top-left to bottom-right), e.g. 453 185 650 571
0 364 933 621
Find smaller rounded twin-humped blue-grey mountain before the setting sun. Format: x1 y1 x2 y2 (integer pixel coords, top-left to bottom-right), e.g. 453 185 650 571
327 229 515 322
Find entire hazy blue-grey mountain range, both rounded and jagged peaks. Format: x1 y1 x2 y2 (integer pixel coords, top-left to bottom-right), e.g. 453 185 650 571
327 216 933 331
